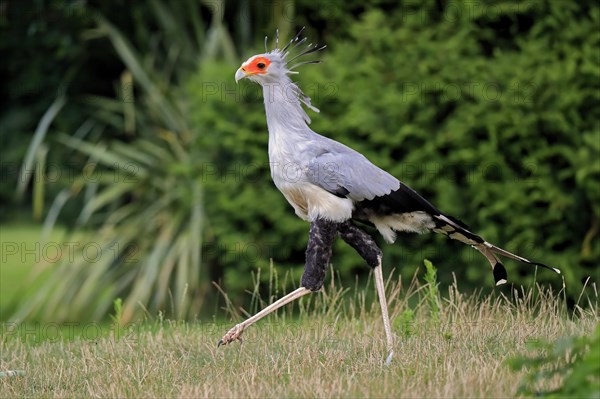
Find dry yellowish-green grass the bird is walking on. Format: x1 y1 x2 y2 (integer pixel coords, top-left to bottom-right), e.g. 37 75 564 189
0 270 599 398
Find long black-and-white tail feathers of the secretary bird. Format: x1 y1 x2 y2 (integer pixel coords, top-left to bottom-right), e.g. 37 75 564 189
433 214 560 285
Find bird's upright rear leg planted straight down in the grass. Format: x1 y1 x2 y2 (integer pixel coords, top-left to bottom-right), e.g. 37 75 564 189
338 221 394 364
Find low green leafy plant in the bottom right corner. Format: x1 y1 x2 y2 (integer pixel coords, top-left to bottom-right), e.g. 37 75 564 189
509 324 600 399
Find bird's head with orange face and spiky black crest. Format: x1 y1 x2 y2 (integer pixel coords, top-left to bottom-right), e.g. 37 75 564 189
235 28 326 85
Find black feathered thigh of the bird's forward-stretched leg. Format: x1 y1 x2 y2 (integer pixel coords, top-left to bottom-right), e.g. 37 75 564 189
301 219 339 291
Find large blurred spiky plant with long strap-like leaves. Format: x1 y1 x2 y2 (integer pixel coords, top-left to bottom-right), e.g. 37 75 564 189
14 1 220 321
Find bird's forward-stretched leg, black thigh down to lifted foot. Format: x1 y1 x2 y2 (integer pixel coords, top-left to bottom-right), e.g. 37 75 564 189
217 219 337 346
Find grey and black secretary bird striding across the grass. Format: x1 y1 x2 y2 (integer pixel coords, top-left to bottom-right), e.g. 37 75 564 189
218 28 560 364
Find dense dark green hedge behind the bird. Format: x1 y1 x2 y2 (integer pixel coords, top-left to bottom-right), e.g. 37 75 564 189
189 1 600 295
